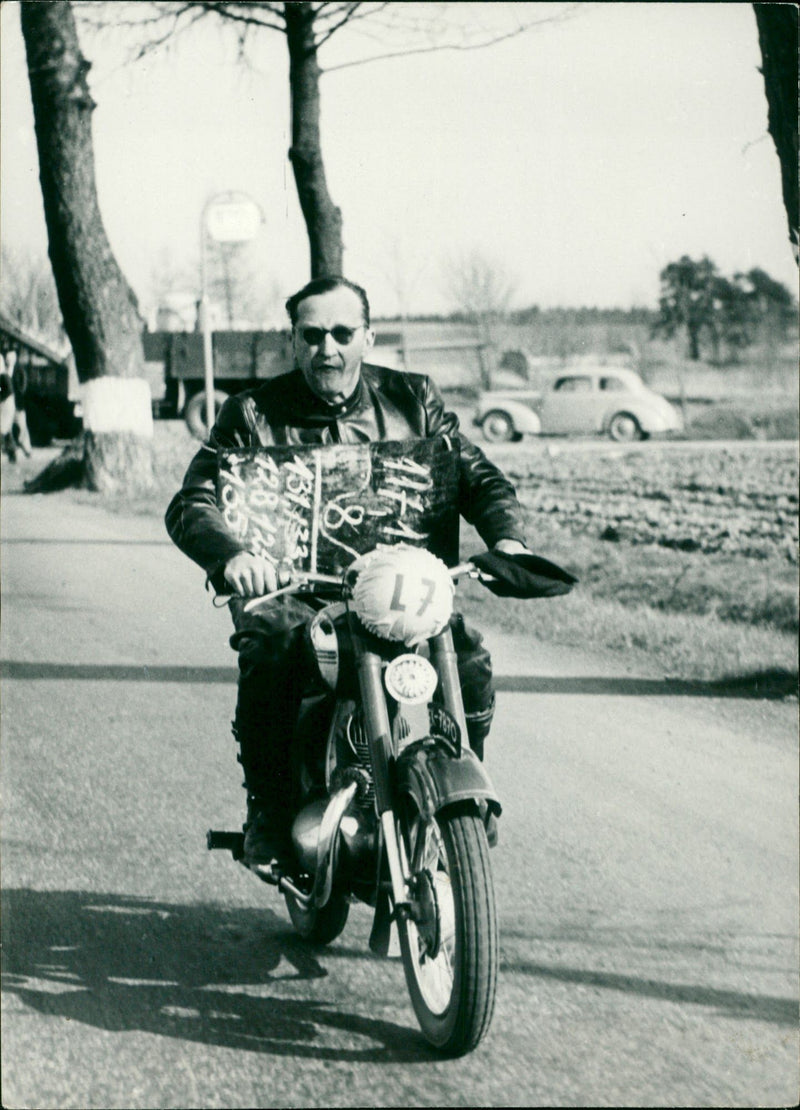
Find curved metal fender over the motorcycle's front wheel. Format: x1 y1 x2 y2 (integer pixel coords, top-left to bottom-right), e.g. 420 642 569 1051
395 737 503 818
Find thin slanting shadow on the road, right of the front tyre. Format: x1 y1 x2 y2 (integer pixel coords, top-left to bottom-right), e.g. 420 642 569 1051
500 960 800 1028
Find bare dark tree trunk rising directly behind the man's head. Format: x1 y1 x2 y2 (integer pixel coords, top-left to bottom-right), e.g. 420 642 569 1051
284 0 343 278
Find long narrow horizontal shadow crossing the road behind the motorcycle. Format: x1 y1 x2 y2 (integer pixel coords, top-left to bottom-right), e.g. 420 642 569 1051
1 659 798 700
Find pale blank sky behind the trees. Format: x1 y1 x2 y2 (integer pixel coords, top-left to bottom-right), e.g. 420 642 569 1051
0 2 798 316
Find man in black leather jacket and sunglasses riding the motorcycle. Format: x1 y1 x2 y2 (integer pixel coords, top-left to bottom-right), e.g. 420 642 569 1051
165 276 527 867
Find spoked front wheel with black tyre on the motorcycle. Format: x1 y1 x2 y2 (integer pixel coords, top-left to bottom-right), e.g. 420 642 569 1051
397 807 498 1056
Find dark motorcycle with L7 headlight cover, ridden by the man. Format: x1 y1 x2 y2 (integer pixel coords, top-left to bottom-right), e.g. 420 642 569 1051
207 545 576 1056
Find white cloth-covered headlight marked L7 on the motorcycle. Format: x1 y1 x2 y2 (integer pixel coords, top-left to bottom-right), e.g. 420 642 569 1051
352 546 454 647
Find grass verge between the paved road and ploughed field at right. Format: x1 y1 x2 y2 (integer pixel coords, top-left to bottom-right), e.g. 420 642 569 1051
459 521 798 685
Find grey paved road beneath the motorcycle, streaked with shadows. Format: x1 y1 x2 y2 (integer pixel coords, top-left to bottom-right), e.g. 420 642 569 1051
1 494 799 1108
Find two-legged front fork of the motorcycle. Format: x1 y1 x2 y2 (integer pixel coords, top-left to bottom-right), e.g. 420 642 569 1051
352 625 467 914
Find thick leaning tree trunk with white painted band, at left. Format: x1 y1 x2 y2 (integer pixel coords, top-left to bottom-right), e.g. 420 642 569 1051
20 0 153 492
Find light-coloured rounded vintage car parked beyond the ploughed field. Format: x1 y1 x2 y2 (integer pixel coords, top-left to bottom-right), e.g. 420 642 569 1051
473 366 682 443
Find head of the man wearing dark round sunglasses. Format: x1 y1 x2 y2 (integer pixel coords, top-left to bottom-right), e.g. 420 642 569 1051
292 286 375 404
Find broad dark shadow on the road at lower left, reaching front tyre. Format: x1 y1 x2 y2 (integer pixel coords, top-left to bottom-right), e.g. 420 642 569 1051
2 889 435 1063
